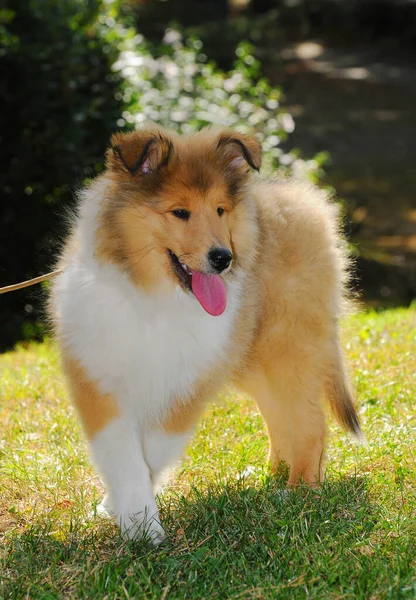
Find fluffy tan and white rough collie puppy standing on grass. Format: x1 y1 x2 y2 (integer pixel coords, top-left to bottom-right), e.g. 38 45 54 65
51 126 362 543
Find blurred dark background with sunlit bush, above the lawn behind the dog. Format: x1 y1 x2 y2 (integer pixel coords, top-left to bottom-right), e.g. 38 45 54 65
0 0 416 350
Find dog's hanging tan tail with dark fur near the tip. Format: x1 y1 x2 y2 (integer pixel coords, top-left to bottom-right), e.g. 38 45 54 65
325 332 367 444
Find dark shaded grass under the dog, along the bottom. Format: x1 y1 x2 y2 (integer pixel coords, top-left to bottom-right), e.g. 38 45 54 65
0 477 394 599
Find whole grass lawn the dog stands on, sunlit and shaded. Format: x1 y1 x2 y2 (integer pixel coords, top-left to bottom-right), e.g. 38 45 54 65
0 310 416 600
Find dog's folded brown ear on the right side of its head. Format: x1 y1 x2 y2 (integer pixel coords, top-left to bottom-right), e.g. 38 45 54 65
217 131 261 173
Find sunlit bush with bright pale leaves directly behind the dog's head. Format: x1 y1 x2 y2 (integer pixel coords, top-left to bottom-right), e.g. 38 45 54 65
113 29 325 178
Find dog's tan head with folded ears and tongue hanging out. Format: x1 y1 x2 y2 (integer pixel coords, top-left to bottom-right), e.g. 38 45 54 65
97 127 261 315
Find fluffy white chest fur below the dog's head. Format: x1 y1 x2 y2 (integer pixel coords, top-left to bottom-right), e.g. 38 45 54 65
55 261 242 419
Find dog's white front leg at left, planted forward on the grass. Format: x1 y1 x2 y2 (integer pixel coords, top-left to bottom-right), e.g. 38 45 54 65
90 418 164 544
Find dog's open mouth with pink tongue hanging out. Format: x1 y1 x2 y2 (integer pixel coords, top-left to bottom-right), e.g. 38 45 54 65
168 249 227 317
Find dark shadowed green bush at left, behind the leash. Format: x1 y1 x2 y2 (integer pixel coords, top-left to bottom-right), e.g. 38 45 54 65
0 0 121 346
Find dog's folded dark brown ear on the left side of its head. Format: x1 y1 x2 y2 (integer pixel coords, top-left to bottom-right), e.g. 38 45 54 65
107 128 173 175
